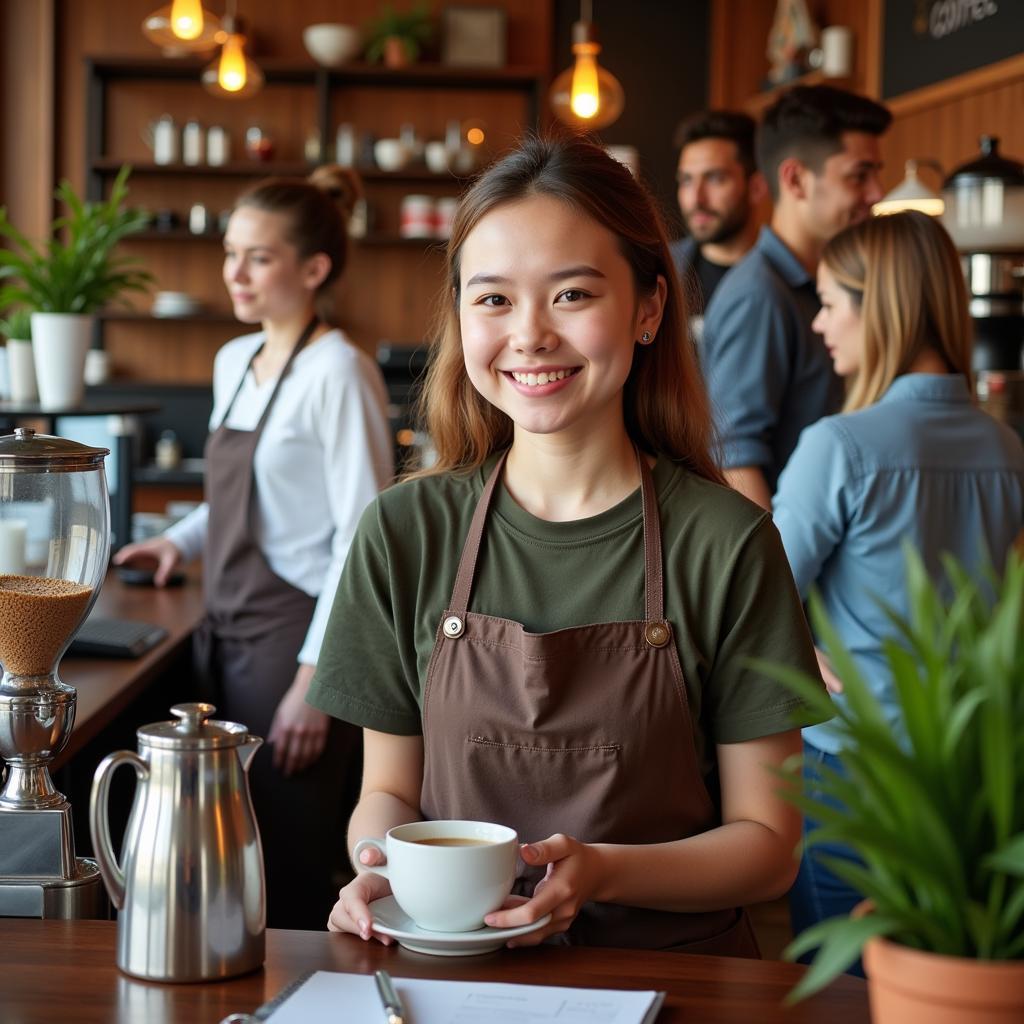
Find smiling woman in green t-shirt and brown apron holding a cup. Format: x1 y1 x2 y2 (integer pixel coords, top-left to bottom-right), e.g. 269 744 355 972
309 139 827 955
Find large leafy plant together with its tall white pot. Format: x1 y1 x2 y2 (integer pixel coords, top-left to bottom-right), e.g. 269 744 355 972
0 165 153 410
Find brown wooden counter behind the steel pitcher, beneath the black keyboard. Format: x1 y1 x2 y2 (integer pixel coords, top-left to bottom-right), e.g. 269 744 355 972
55 567 203 767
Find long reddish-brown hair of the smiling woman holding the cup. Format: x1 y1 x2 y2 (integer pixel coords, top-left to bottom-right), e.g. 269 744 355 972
411 136 723 482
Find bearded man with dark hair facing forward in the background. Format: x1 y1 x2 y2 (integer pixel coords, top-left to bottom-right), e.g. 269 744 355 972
672 111 766 315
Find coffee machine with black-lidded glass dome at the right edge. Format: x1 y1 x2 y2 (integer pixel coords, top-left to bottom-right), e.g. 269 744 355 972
942 135 1024 374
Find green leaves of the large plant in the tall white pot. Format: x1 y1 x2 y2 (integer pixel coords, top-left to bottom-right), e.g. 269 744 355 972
0 165 153 313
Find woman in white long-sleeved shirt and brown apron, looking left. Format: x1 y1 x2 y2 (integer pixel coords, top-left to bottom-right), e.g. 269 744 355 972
115 167 393 928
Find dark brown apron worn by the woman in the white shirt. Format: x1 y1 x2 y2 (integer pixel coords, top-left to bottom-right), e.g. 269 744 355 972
194 317 360 929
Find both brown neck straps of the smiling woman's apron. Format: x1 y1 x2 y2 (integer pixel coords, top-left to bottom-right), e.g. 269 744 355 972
449 449 665 622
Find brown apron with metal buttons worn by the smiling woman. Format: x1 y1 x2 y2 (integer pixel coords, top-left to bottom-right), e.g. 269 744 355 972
422 454 760 956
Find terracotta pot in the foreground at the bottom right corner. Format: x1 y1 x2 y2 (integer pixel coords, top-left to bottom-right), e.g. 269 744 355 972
864 938 1024 1024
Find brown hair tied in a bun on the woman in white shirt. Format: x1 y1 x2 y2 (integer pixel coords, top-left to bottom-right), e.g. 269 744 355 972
234 164 362 324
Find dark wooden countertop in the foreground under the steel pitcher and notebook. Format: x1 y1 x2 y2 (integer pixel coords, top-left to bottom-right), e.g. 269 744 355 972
0 919 868 1024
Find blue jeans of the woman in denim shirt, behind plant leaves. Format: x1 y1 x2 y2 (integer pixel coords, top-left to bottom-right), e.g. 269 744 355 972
790 740 864 978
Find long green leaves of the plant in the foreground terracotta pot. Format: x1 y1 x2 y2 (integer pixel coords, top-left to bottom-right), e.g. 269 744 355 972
759 548 1024 1000
